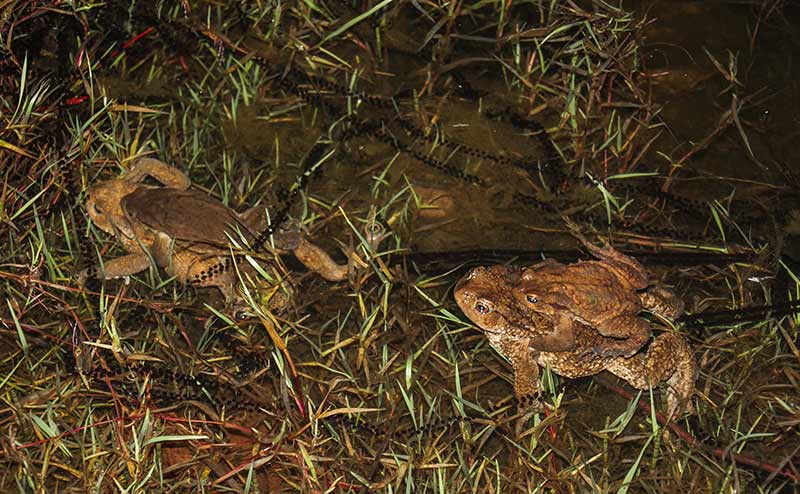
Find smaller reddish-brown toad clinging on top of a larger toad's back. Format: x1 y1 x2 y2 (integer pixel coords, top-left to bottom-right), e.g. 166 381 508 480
515 230 683 357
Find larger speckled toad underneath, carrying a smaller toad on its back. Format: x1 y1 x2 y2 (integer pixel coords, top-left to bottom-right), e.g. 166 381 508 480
455 266 697 416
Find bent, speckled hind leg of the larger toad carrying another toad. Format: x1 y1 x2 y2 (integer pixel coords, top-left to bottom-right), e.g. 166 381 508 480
606 332 698 418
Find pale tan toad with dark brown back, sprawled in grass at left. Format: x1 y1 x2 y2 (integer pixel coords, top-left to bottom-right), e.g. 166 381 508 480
80 158 347 302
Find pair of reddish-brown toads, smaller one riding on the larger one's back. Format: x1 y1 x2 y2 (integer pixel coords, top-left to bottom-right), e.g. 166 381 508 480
455 229 697 418
